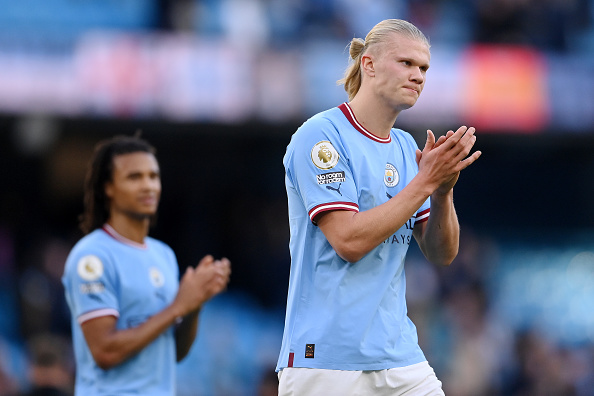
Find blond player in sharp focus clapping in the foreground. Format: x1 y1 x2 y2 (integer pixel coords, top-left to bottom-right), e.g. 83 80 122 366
277 19 481 396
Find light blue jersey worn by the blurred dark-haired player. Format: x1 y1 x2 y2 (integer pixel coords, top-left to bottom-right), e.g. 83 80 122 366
62 225 179 396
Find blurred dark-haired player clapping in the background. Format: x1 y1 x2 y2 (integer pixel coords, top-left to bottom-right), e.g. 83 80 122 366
62 137 230 396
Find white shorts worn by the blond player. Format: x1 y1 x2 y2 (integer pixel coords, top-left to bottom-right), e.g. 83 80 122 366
278 362 445 396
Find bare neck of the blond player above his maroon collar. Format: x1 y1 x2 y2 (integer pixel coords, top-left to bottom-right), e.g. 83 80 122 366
349 92 400 138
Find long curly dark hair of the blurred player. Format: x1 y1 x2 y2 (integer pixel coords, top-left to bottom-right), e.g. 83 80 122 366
79 134 156 234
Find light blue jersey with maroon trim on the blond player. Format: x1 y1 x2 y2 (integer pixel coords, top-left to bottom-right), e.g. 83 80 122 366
277 103 430 371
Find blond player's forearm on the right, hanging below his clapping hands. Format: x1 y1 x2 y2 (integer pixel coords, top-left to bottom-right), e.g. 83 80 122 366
419 190 460 265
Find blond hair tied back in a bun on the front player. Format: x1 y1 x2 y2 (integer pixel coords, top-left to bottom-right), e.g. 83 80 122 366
337 19 430 100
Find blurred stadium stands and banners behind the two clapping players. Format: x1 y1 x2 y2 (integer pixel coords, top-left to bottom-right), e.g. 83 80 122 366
0 0 594 396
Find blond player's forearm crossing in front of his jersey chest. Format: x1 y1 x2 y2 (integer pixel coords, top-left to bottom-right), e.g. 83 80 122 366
318 178 432 262
